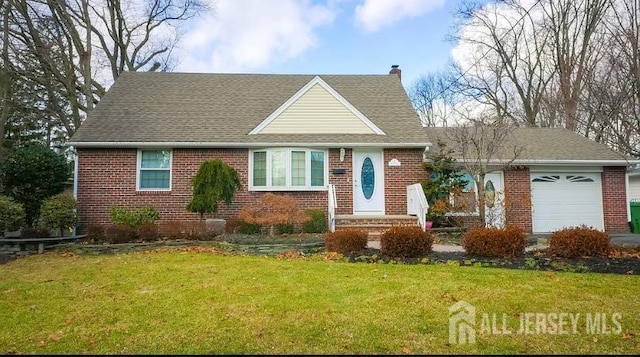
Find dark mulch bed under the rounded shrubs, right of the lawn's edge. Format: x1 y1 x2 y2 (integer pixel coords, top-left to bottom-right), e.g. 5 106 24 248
348 247 640 275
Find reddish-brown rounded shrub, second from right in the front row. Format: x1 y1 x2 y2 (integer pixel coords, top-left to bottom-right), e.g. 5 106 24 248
462 226 527 258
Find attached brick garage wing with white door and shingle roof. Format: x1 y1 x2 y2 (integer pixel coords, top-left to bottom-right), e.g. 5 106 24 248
426 128 640 233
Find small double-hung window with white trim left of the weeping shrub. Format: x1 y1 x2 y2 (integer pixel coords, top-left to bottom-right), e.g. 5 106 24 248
136 150 172 191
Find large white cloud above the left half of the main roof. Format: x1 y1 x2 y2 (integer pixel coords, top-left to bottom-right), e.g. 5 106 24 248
178 0 335 72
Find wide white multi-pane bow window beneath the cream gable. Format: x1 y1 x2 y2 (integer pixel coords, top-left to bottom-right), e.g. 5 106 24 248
249 148 329 191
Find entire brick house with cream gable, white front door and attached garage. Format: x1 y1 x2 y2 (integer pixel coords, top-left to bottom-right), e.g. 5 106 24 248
69 66 629 232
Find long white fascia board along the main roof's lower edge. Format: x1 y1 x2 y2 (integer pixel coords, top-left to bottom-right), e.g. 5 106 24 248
66 141 431 149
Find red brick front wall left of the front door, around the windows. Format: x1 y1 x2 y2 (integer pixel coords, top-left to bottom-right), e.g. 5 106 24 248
77 149 335 231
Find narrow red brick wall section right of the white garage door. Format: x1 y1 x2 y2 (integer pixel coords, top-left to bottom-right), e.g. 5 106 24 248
602 166 630 233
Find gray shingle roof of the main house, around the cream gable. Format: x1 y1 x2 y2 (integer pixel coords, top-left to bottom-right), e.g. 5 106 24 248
70 72 428 146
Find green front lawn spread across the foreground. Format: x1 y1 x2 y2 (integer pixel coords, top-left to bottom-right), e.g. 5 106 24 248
0 251 640 354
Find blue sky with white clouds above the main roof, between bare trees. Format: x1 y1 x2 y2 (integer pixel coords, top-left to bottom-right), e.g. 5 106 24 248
176 0 458 87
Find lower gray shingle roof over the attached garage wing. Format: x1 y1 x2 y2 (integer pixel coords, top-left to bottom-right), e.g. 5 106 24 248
424 128 637 165
